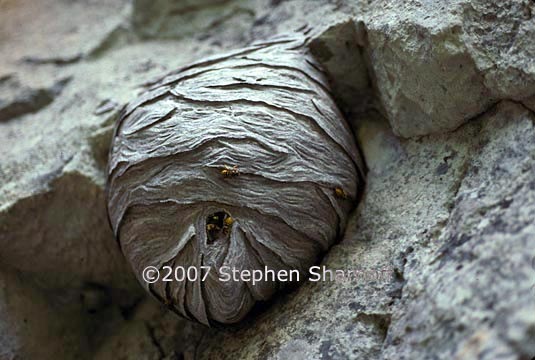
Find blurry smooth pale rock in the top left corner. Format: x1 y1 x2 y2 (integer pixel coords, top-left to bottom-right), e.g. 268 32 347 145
0 0 126 65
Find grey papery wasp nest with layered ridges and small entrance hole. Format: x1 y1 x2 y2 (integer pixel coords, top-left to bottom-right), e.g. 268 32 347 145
108 37 361 325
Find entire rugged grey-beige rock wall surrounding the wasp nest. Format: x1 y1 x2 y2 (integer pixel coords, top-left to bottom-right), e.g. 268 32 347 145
0 0 535 360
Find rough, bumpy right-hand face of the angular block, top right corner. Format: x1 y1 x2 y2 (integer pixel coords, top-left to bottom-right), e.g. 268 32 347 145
460 1 535 101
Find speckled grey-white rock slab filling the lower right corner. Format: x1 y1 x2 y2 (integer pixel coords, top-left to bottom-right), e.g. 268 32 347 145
382 102 535 359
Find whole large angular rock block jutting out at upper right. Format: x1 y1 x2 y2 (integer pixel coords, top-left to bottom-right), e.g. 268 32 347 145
365 0 535 137
